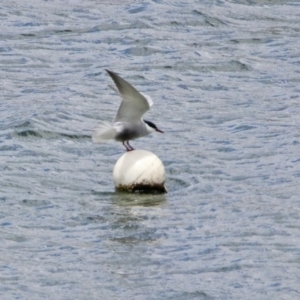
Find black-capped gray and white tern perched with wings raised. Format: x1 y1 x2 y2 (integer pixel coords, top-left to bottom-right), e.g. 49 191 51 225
92 69 164 152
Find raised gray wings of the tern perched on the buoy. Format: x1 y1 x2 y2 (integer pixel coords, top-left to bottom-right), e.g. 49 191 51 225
106 70 153 122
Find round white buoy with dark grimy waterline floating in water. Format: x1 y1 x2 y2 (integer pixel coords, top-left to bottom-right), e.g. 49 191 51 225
113 150 167 193
